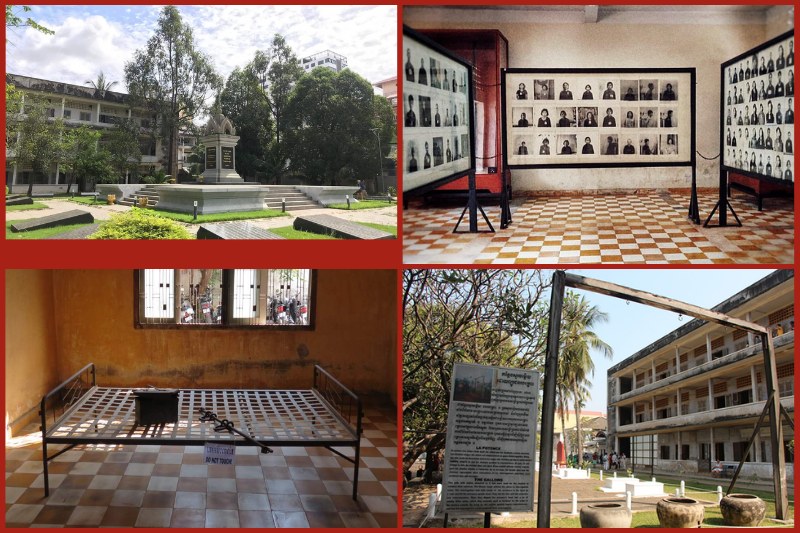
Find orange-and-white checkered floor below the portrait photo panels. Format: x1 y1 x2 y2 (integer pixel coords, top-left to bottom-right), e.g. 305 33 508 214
403 192 794 264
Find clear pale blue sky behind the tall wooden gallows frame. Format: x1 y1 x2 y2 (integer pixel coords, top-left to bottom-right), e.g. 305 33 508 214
564 268 773 413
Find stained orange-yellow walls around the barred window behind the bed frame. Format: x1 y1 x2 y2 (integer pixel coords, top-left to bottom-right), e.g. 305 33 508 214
6 270 397 426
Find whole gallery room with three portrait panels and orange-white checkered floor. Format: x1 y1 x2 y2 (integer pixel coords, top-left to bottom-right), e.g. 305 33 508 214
400 5 794 264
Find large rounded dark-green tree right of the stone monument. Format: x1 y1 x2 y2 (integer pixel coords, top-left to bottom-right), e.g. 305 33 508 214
287 68 391 185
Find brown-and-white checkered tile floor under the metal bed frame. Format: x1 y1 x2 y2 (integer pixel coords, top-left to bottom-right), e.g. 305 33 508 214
6 402 398 527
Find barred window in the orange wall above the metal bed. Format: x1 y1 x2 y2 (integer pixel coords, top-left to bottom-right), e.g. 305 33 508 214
134 269 316 329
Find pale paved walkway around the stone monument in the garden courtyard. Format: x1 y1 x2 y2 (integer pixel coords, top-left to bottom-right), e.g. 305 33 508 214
6 199 397 238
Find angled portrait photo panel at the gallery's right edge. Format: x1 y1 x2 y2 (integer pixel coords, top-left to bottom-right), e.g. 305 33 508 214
720 31 794 183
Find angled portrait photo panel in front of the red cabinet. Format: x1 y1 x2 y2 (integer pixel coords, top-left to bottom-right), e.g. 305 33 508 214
403 27 475 193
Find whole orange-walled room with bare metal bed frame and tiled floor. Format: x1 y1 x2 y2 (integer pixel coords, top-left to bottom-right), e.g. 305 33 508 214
5 269 398 527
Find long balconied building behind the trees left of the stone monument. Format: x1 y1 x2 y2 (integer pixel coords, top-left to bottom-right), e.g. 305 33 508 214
6 74 162 188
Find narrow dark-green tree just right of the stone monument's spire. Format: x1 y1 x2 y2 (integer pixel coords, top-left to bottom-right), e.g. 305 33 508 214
220 65 272 177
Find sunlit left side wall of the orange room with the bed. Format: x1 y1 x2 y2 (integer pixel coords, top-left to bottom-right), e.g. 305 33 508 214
5 270 59 436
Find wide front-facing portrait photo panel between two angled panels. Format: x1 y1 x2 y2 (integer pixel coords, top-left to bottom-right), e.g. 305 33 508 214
502 69 695 168
